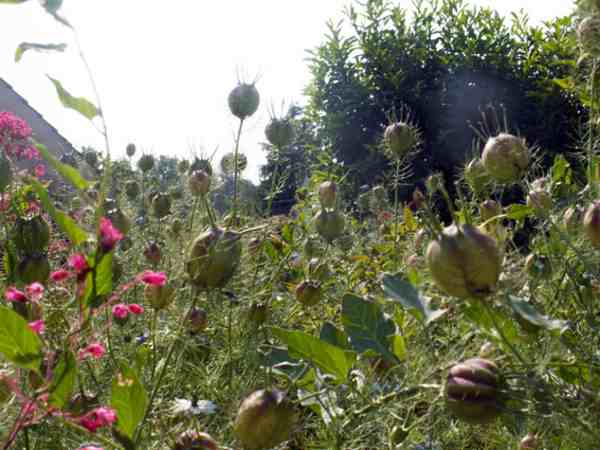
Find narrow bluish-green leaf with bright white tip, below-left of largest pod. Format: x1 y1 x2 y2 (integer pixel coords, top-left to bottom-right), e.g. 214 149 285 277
383 273 446 324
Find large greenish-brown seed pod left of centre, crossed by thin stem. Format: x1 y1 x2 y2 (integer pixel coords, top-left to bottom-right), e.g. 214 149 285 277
186 227 242 288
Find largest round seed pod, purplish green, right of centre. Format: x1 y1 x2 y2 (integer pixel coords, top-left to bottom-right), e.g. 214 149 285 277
426 225 501 299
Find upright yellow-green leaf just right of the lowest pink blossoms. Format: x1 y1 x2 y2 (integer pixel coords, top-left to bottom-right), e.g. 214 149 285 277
110 365 148 439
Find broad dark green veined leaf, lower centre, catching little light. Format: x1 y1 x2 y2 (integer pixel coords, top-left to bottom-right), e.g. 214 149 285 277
342 294 398 363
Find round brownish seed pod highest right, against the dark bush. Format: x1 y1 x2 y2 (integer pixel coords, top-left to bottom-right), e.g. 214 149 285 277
481 133 529 183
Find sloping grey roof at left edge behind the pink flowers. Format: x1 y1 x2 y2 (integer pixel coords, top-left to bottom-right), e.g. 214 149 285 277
0 78 76 157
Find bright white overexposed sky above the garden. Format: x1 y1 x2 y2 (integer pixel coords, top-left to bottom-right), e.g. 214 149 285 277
0 0 573 182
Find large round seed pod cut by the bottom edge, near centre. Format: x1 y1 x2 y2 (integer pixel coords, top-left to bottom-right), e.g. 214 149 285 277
233 389 296 450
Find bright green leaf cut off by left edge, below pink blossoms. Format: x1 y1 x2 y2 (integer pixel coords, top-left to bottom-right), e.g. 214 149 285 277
0 306 44 374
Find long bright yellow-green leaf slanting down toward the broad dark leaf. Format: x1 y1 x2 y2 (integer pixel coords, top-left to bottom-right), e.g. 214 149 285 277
271 327 356 382
